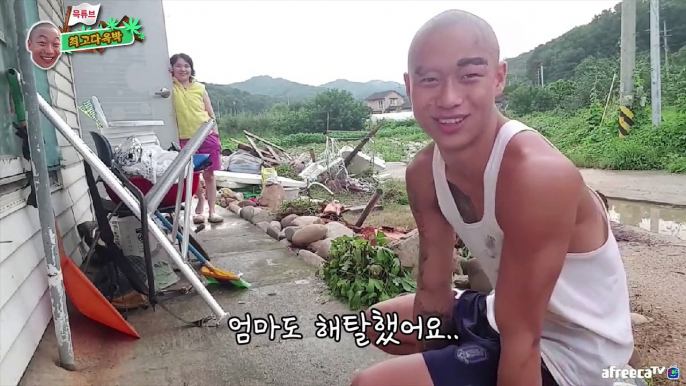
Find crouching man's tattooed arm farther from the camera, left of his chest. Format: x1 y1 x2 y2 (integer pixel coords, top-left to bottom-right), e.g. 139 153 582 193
405 146 455 351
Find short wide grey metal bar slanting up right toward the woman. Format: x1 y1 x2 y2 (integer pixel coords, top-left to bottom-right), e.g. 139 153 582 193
145 119 215 213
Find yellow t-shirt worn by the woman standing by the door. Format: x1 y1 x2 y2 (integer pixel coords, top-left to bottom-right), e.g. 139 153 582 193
173 79 210 139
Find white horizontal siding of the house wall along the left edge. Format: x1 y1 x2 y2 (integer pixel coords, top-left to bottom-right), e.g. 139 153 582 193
0 0 93 386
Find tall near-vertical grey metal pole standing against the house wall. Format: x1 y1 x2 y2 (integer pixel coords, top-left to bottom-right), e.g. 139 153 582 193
14 0 76 371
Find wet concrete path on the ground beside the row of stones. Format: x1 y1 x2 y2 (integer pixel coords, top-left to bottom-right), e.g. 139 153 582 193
20 210 387 386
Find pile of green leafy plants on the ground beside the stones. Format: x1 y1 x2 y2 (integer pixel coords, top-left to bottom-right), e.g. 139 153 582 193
318 232 417 310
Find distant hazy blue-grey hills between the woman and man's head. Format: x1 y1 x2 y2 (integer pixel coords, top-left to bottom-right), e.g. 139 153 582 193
228 75 405 102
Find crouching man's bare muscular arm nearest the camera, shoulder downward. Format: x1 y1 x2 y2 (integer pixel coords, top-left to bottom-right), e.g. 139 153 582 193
495 152 585 386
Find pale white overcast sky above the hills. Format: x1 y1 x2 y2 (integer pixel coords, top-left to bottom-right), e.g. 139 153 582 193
163 0 619 85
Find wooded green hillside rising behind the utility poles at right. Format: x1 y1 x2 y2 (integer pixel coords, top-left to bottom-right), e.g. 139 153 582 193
508 0 686 83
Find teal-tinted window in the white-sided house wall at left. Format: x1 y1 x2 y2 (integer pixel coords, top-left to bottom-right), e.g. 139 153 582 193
0 1 60 185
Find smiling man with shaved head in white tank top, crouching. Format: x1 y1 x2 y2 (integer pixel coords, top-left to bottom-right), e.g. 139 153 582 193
353 11 633 386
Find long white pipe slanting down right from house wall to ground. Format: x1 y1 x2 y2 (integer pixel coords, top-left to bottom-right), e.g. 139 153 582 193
38 95 229 324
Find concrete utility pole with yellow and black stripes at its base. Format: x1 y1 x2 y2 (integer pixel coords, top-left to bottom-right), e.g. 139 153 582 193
619 0 636 137
